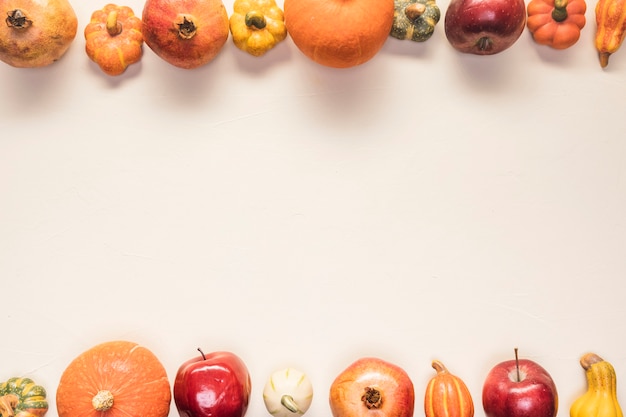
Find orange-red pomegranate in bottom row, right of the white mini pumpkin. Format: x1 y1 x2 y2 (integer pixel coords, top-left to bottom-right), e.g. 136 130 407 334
330 358 415 417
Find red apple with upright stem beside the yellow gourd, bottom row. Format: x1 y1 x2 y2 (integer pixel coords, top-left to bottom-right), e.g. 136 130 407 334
483 359 558 417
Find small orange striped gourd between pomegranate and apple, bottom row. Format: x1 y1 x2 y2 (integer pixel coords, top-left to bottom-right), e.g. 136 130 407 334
424 360 474 417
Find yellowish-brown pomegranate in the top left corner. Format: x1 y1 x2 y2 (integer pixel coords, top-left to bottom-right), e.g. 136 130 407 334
0 0 78 68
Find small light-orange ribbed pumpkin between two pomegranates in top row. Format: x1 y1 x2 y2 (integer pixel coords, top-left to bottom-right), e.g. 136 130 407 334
85 4 143 75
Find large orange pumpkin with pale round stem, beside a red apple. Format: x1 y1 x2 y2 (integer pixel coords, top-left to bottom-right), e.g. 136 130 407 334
56 341 171 417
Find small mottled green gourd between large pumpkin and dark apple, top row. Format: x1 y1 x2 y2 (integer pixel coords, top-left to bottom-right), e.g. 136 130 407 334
390 0 441 42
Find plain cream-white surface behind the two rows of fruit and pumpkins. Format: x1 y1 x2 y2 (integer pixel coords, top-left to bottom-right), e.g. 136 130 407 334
0 0 626 417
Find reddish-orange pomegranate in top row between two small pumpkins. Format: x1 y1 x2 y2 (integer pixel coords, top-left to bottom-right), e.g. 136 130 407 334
142 0 229 69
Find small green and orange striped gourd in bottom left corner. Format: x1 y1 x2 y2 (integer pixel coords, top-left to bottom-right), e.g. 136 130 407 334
0 378 48 417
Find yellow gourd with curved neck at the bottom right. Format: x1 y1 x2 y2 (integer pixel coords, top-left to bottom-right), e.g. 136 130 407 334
570 353 623 417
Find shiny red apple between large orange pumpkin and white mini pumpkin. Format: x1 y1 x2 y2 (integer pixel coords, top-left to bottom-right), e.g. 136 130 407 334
174 349 251 417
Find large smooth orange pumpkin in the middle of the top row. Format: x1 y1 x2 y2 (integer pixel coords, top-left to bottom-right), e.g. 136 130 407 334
284 0 394 68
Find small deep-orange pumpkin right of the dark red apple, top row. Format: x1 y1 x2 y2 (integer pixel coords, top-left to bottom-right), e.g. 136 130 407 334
526 0 587 49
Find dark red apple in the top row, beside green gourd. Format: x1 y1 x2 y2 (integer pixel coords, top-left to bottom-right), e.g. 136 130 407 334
444 0 526 55
